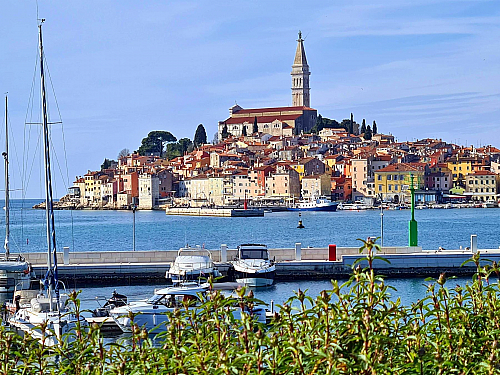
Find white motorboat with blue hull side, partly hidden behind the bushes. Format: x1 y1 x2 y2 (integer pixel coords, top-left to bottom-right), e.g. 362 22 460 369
109 282 266 333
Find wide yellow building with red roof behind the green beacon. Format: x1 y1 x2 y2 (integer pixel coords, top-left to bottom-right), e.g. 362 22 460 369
375 163 428 202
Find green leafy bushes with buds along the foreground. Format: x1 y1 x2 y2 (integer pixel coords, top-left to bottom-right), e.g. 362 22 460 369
0 242 500 374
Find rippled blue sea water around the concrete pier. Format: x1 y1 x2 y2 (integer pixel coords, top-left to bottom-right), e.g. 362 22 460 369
0 200 500 316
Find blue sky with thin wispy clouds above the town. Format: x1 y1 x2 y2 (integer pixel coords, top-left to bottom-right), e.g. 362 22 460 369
0 0 500 198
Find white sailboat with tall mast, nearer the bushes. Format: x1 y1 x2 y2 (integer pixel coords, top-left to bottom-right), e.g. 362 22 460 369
9 19 86 346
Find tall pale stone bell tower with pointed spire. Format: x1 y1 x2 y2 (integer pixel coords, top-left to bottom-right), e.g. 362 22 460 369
291 31 311 107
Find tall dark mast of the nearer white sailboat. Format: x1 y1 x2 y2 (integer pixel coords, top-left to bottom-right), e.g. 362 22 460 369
38 20 59 311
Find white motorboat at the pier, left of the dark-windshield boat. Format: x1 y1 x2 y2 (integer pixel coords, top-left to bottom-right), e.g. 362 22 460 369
166 246 221 283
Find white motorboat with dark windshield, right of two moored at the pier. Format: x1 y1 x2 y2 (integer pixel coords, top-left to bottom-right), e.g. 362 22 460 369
232 244 276 287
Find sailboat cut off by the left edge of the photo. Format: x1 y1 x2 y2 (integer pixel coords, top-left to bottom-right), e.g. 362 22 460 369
0 95 31 305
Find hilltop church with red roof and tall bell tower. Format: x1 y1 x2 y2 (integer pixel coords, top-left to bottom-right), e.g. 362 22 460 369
218 31 317 140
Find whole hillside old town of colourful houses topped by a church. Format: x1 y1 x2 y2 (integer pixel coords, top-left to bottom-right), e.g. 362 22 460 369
54 32 500 209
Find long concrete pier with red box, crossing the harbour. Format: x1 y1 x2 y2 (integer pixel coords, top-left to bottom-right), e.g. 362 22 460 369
23 238 500 288
